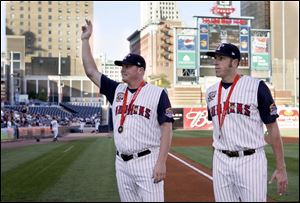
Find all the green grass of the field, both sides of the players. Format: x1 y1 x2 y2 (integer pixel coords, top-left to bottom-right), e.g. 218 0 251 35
1 131 299 202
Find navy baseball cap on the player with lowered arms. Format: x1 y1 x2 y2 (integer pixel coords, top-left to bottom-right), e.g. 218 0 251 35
206 43 241 61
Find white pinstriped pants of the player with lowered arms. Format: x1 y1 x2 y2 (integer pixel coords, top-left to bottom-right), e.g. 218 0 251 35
213 148 267 202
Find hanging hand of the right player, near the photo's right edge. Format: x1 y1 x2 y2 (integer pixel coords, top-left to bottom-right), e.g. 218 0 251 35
269 168 288 195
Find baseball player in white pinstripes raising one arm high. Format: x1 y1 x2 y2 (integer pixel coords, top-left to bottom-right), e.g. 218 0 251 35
81 20 174 202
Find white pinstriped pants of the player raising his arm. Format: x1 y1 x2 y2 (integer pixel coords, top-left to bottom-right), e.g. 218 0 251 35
116 149 164 202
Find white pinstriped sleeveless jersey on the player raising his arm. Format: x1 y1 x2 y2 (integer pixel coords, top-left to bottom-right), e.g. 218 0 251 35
112 83 163 154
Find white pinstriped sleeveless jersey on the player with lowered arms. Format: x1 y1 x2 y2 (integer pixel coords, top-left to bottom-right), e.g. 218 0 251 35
206 76 266 151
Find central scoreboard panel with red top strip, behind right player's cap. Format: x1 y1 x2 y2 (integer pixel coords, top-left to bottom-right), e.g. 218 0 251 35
197 17 251 67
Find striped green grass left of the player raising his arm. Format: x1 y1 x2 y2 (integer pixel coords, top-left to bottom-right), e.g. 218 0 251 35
1 137 120 202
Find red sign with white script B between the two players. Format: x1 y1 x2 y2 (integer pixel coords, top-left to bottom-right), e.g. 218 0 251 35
183 108 213 130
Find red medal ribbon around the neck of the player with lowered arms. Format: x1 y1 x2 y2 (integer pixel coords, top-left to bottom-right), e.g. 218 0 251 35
218 74 240 130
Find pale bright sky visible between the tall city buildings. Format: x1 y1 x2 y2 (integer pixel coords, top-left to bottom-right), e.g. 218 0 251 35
1 1 240 60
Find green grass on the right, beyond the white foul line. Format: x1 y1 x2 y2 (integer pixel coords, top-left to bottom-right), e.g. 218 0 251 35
172 131 299 202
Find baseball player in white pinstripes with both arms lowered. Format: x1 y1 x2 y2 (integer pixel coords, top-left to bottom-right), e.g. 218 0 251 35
206 43 288 202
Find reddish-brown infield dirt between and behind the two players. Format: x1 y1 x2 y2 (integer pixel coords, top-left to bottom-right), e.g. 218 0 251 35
165 137 299 202
